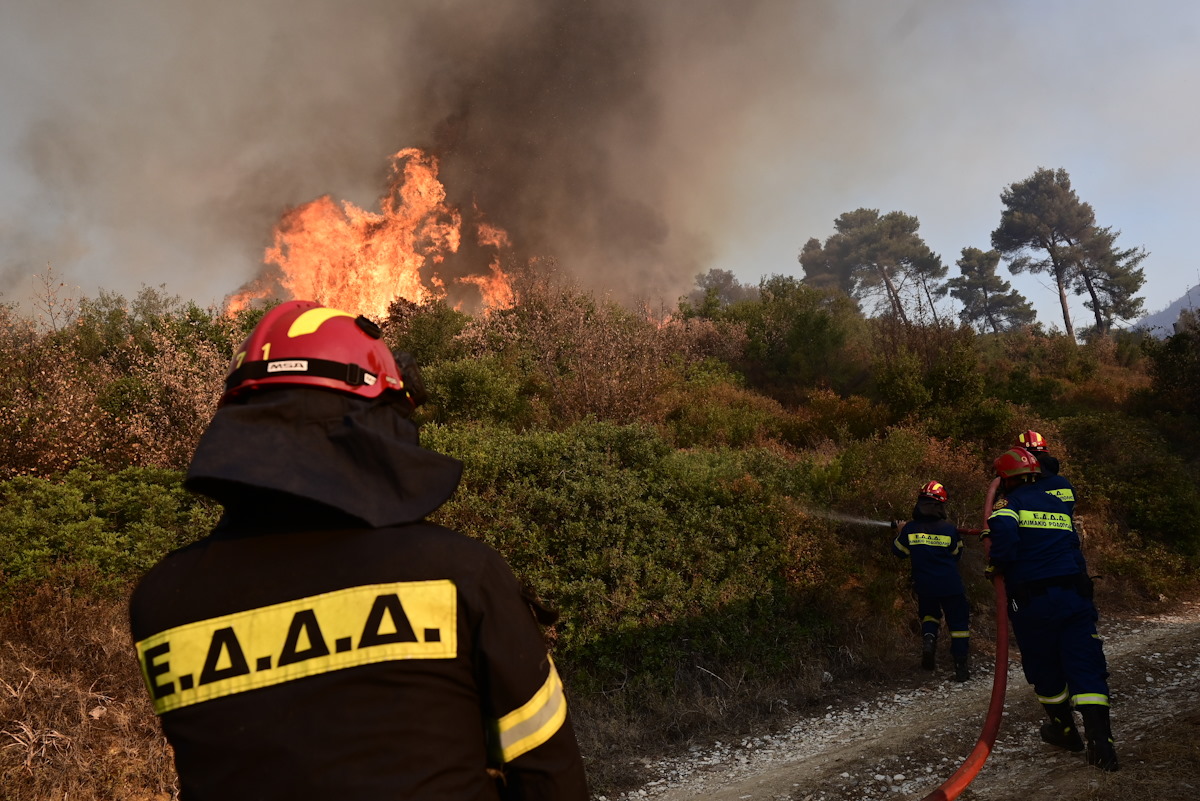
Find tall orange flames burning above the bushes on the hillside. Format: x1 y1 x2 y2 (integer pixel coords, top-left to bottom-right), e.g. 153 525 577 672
227 147 512 319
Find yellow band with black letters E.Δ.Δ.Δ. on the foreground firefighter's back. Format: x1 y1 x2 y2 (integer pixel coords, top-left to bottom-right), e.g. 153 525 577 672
137 579 458 715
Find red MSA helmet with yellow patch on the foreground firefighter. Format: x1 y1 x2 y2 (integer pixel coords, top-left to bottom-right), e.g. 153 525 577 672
221 301 424 408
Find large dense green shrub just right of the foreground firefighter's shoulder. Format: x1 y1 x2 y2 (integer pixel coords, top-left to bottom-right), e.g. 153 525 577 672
422 423 844 683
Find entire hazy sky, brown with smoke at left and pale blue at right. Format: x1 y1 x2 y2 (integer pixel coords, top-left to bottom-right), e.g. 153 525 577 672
0 0 1200 326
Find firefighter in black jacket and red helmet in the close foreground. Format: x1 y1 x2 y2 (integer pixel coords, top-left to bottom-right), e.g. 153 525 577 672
131 301 587 801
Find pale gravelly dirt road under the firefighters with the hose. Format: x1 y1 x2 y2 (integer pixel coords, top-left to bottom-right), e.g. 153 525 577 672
609 603 1200 801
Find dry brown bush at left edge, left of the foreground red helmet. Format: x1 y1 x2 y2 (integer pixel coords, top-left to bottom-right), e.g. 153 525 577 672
0 297 233 478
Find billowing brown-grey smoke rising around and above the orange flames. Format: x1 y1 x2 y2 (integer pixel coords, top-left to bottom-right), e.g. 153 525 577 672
0 0 820 302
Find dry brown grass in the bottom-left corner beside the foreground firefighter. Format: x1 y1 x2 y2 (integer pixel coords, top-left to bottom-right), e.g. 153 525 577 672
0 589 176 801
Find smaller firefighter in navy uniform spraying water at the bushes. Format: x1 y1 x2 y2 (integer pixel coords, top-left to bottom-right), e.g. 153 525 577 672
892 481 971 681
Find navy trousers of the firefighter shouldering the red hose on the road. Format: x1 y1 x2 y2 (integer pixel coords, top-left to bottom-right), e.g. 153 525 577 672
1009 586 1109 706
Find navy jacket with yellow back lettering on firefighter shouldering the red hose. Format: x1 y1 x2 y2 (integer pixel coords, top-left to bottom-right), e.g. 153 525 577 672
988 480 1085 592
